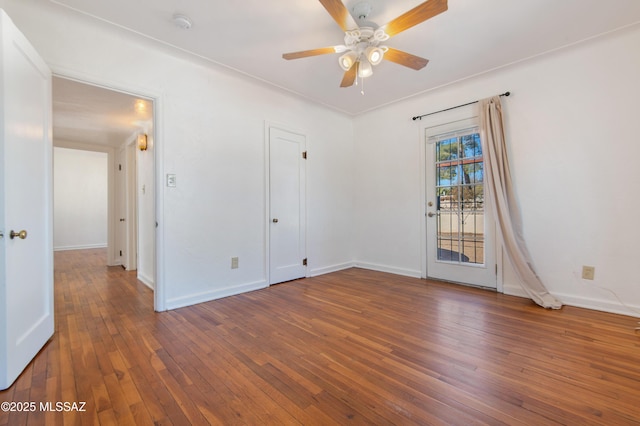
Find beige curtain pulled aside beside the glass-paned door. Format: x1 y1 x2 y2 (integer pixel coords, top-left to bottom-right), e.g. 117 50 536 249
479 96 562 309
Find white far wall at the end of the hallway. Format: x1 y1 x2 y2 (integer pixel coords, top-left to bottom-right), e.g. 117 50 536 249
53 147 108 250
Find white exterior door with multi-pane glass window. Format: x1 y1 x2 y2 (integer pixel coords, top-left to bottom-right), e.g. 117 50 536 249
425 119 497 288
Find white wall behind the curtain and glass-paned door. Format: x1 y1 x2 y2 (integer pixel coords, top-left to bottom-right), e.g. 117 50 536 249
355 26 640 315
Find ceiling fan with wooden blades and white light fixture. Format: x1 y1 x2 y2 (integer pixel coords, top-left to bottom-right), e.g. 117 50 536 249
282 0 447 87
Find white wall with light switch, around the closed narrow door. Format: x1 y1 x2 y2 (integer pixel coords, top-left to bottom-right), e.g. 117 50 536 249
0 0 353 308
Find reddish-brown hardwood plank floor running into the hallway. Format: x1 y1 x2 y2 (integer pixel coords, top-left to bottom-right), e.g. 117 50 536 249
0 250 640 426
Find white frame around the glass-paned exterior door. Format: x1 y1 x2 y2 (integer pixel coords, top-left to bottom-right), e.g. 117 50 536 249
418 105 503 293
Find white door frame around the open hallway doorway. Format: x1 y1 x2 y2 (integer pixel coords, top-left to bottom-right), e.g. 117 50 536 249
49 65 167 312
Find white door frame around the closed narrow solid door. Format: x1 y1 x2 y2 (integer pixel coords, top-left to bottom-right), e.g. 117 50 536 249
263 121 309 287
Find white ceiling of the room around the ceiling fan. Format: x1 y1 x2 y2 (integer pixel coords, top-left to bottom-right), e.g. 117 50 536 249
51 0 640 145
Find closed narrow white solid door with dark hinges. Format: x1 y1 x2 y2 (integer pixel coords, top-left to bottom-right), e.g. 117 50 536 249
269 128 306 284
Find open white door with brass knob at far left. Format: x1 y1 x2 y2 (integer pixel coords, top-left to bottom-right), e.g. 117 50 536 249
0 10 54 390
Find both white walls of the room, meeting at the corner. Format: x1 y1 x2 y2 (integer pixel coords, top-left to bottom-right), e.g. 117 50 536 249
0 0 640 313
